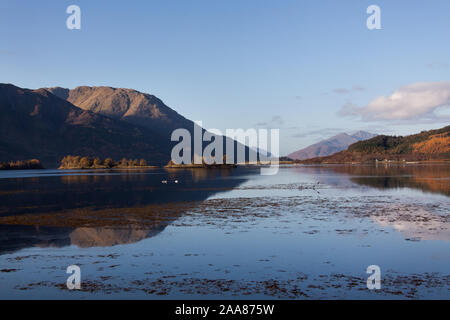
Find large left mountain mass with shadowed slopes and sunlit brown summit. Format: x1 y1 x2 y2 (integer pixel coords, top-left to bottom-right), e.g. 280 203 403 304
0 84 253 167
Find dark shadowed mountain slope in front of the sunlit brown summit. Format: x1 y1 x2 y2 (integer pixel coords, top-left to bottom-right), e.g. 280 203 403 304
0 84 170 167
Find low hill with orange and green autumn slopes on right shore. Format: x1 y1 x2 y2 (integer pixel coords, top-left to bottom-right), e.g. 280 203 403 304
302 126 450 163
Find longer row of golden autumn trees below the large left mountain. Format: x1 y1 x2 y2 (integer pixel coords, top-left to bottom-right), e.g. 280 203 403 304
60 155 148 169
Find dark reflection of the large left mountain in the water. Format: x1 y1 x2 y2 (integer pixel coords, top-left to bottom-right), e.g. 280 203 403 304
0 169 247 253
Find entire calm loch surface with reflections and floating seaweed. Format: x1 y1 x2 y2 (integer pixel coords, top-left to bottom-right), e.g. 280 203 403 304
0 165 450 299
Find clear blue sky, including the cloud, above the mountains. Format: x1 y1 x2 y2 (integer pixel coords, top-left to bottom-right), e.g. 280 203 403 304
0 0 450 155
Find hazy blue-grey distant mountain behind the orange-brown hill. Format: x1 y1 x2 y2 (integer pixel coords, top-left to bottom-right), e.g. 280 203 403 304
288 131 376 160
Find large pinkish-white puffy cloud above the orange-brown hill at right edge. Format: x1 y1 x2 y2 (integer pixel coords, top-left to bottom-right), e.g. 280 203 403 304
339 81 450 121
